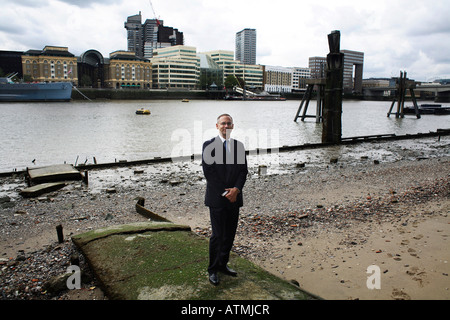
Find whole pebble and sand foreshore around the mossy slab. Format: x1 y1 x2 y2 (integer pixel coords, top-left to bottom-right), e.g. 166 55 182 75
0 137 450 300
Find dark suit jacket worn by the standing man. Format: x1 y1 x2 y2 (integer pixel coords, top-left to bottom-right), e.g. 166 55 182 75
202 136 248 208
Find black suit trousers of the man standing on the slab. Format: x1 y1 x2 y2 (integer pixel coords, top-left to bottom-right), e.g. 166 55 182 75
208 205 239 273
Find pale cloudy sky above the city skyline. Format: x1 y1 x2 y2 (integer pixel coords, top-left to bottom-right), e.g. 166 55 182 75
0 0 450 81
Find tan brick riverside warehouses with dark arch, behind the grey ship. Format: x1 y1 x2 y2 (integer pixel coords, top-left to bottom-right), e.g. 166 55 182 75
0 46 152 89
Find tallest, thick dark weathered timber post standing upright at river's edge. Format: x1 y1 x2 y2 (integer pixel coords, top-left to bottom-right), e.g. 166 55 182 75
322 31 344 143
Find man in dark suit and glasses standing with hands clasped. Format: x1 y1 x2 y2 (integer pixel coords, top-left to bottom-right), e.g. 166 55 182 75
202 114 248 285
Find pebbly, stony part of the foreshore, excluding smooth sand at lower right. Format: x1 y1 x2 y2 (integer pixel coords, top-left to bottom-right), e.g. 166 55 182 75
0 139 450 300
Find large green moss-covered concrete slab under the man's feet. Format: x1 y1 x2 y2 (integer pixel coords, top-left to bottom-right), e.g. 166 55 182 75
72 222 319 300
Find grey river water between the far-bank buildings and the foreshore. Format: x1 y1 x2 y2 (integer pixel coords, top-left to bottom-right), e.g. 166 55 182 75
0 100 450 172
